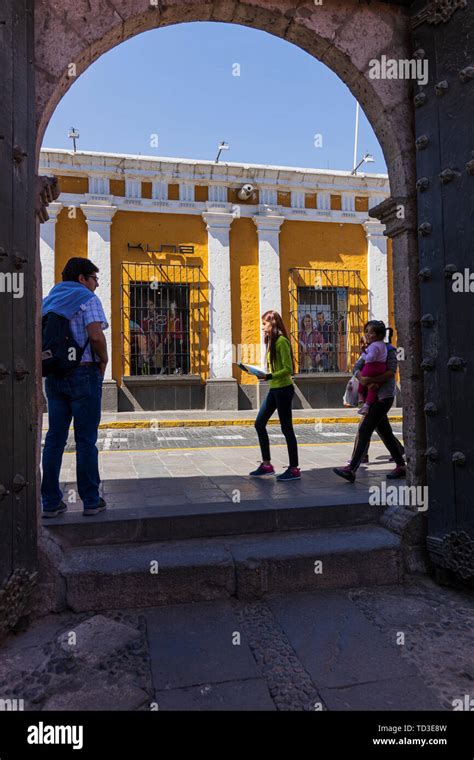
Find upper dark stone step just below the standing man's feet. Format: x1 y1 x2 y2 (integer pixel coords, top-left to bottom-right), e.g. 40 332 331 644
44 492 381 548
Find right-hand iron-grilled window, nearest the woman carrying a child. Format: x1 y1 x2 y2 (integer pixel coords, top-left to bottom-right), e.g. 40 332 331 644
290 268 367 374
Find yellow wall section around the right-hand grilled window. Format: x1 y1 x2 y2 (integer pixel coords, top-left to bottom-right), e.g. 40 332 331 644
280 221 368 372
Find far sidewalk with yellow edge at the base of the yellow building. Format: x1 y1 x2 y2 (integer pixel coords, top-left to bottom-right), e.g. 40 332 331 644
43 407 402 430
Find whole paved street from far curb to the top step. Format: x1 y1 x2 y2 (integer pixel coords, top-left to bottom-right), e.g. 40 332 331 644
43 425 401 513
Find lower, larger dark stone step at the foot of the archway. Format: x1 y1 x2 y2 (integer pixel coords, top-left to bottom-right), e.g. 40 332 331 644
59 525 402 612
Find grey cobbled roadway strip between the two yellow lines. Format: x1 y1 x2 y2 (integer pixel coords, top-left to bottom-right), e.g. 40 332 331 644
42 423 402 452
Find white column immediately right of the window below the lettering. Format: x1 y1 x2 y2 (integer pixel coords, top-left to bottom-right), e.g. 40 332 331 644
202 211 234 379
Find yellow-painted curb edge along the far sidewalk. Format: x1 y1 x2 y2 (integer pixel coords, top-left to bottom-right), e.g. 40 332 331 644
99 415 403 430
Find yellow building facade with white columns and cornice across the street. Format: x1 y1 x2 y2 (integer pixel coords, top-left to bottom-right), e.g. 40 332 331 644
40 150 393 410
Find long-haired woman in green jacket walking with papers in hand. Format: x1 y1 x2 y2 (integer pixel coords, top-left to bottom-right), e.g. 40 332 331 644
250 311 301 481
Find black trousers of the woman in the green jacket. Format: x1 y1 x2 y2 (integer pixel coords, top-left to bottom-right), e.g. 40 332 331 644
255 383 298 467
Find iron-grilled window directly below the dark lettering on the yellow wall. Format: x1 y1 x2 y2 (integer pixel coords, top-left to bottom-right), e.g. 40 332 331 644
121 263 202 376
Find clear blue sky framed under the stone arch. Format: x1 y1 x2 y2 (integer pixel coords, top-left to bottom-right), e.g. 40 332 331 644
43 23 386 172
